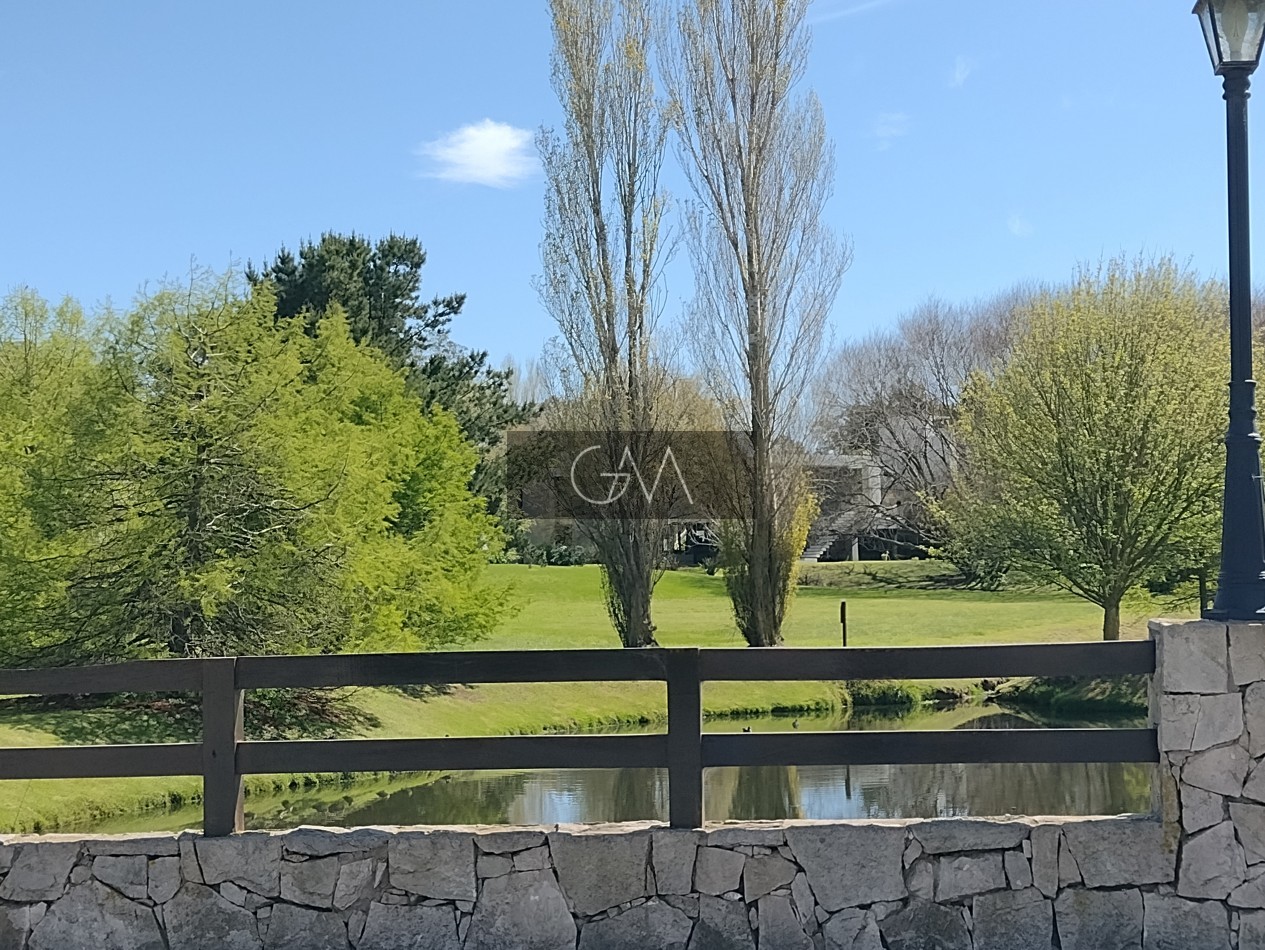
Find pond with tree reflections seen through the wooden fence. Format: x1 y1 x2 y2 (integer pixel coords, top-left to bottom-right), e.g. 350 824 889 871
74 705 1155 831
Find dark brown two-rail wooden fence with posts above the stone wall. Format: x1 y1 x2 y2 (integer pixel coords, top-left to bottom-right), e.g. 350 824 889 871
0 640 1159 835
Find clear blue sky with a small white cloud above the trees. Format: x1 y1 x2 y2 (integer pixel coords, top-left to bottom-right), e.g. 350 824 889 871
0 0 1265 361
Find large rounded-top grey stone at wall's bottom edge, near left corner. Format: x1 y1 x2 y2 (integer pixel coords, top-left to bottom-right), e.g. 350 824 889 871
28 880 164 950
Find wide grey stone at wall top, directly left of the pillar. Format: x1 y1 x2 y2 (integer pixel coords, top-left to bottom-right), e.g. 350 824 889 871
1063 817 1176 887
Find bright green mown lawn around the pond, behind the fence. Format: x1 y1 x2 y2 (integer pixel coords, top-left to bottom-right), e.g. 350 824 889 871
0 562 1171 831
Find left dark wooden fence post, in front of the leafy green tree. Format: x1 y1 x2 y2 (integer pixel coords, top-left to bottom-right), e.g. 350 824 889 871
202 657 245 837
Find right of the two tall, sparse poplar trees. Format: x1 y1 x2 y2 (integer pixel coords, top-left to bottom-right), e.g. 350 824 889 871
664 0 850 646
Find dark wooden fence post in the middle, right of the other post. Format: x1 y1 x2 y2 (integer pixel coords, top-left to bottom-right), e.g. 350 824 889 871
665 648 703 829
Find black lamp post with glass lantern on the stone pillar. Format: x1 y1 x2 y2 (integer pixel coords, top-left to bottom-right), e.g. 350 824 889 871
1194 0 1265 621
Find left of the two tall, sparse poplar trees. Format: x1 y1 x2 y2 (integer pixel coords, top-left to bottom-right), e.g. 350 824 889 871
538 0 672 646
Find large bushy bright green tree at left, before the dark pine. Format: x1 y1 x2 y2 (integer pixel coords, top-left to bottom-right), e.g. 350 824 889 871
0 278 505 662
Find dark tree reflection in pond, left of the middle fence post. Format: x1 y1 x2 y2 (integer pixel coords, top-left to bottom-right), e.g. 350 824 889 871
339 773 530 826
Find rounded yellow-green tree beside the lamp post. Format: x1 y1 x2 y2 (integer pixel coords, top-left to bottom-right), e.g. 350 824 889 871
942 259 1227 640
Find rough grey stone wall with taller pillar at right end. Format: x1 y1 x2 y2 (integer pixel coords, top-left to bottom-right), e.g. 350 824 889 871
0 621 1265 950
